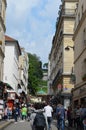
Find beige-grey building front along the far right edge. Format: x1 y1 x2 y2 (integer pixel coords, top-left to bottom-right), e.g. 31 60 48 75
72 0 86 106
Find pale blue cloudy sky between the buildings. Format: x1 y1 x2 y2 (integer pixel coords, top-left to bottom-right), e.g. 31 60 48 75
6 0 61 63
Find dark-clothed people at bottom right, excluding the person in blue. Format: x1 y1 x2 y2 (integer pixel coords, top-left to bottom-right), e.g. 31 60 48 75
67 104 86 130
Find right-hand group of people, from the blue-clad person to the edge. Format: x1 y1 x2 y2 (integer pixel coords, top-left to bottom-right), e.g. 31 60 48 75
56 104 86 130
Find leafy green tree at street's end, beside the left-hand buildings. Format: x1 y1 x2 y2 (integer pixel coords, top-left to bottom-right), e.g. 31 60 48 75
28 53 43 95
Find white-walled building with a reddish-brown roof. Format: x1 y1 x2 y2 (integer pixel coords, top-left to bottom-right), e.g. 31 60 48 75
3 36 21 100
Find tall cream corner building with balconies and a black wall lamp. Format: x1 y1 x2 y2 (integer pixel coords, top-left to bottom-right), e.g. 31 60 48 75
48 0 77 107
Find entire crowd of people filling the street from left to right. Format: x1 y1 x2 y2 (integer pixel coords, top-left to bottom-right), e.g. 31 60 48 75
4 102 86 130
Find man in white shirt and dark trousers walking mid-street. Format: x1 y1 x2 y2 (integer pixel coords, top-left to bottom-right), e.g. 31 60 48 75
44 103 53 130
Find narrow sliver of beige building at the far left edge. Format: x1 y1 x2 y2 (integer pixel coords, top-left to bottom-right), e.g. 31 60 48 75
0 0 7 81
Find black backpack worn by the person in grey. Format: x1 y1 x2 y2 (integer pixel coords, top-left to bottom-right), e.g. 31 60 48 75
34 113 46 127
